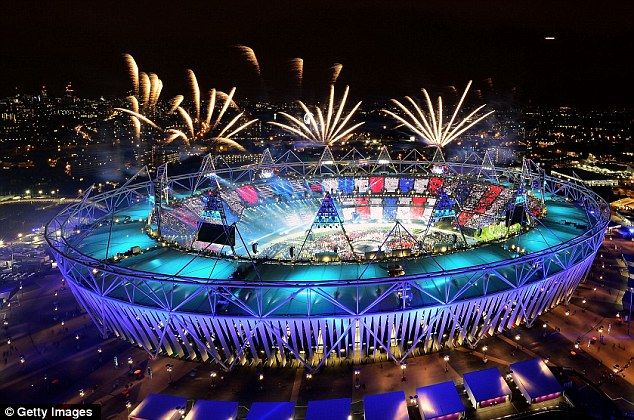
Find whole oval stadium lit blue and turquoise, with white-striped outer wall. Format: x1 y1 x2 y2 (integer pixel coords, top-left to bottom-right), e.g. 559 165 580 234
46 147 609 370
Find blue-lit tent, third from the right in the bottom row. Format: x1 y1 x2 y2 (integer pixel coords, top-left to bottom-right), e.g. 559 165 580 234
416 381 465 419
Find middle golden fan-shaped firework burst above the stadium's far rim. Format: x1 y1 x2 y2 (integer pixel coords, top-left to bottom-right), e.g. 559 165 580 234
269 86 363 146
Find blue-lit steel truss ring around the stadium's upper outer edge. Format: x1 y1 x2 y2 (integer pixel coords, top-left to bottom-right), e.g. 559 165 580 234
45 151 609 288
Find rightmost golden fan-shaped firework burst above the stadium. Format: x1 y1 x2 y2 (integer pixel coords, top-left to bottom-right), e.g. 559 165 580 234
384 81 493 147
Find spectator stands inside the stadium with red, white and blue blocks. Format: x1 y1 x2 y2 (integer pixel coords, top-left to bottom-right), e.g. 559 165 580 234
156 176 520 259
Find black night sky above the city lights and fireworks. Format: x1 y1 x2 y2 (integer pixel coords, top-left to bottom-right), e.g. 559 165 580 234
0 0 634 106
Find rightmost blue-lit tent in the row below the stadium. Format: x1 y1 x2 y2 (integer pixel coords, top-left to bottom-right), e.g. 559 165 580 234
511 358 563 402
